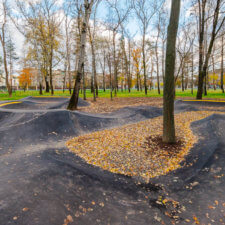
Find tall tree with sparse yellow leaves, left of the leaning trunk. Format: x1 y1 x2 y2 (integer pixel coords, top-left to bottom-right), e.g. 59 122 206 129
15 0 63 95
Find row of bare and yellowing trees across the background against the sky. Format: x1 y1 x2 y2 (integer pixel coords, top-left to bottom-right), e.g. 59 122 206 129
0 0 224 99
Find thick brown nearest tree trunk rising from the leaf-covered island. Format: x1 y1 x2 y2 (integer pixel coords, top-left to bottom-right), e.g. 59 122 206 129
163 0 180 143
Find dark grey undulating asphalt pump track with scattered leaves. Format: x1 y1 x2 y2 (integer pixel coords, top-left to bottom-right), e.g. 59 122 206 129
0 97 225 225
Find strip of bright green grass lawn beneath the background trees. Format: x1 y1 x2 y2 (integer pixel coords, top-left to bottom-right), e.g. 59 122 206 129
0 89 225 101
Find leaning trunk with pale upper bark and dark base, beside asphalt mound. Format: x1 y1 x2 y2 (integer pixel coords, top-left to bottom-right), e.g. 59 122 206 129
67 0 93 110
